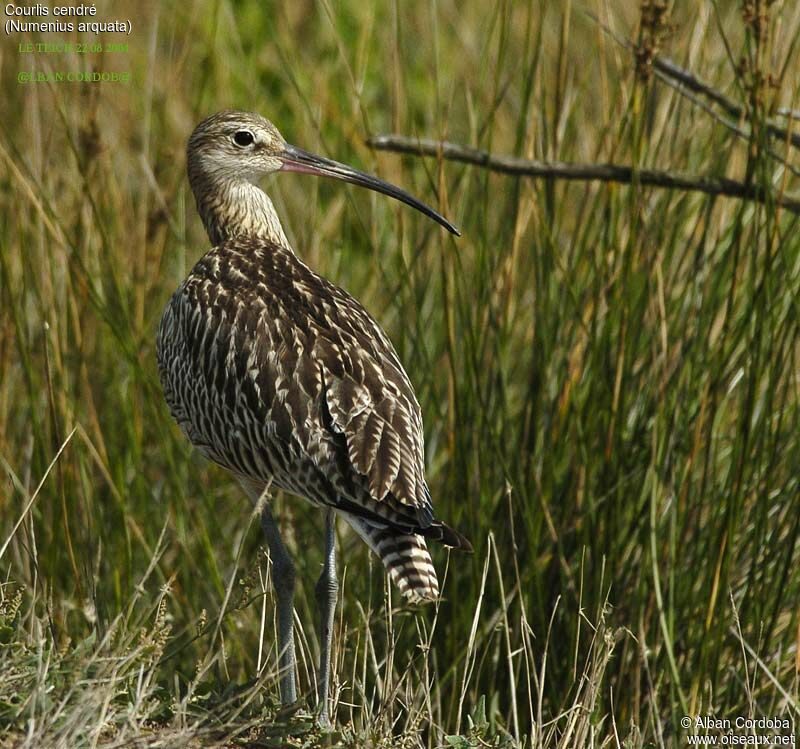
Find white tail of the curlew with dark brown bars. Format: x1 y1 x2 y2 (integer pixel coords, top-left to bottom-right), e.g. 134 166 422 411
346 515 439 603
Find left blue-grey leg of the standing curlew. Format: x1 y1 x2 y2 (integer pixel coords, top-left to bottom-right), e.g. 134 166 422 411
261 503 297 705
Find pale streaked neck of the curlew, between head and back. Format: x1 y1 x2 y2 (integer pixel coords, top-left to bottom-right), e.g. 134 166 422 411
189 168 291 250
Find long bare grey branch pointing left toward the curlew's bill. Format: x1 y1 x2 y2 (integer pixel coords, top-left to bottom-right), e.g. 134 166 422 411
367 135 800 214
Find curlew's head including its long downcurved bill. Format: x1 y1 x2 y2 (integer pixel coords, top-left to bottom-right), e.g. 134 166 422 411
187 110 460 235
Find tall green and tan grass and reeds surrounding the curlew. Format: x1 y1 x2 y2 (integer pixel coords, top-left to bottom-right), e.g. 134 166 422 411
0 0 800 748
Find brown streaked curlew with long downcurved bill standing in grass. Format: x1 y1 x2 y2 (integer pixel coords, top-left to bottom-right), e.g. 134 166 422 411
156 110 472 727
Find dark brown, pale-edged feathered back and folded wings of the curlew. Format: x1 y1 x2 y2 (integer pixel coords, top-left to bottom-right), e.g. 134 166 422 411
160 237 433 528
